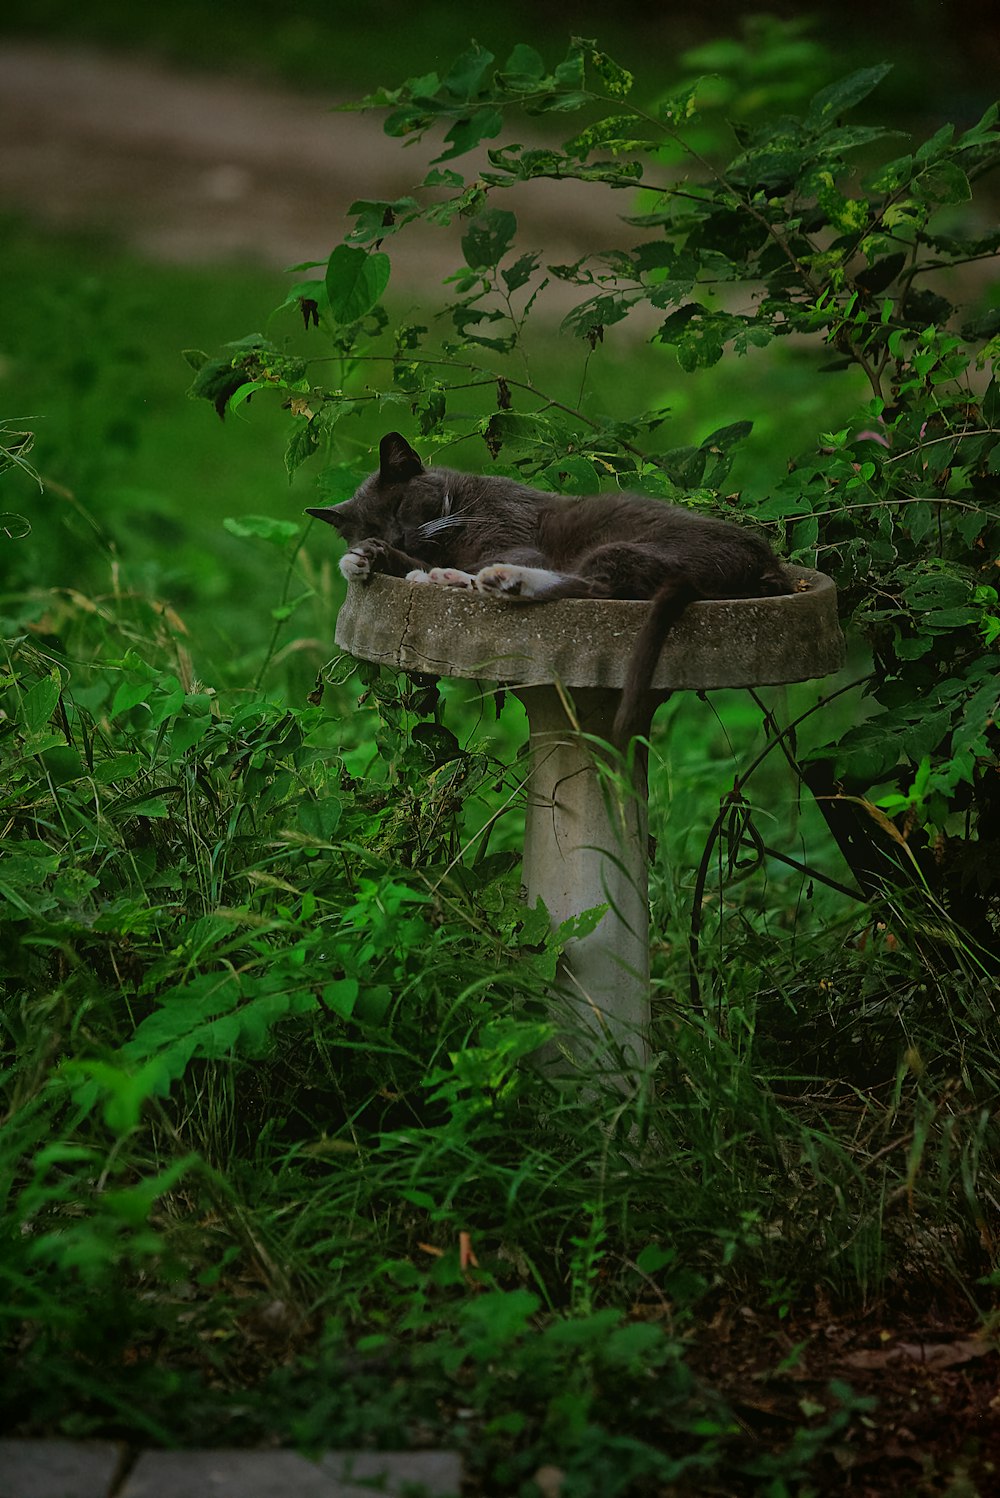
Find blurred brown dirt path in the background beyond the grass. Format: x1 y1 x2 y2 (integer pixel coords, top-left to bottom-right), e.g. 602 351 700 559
0 42 629 285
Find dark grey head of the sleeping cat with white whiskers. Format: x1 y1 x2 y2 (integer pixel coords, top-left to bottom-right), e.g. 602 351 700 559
305 431 452 557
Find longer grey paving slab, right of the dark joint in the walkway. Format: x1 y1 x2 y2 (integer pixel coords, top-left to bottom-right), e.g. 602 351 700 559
121 1450 461 1498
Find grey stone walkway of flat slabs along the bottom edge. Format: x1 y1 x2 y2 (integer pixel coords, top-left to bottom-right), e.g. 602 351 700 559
0 1441 461 1498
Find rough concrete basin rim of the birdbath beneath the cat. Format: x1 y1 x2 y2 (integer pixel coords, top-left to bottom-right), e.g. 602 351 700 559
337 568 844 691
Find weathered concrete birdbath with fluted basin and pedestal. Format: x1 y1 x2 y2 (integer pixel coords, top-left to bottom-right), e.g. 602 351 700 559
337 568 844 1082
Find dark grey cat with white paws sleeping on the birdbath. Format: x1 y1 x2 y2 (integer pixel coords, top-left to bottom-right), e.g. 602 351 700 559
307 431 793 748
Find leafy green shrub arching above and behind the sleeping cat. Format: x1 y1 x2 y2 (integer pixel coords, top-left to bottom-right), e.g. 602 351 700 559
185 39 1000 947
